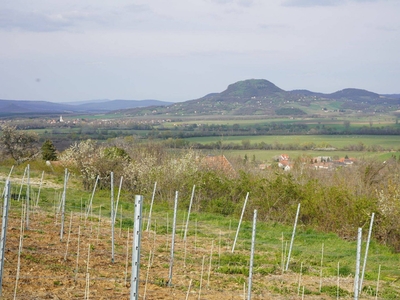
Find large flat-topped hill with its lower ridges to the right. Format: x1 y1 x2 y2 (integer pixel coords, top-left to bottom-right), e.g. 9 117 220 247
118 79 400 116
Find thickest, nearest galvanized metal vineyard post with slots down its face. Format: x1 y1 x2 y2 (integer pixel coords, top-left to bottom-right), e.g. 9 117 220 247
130 195 143 300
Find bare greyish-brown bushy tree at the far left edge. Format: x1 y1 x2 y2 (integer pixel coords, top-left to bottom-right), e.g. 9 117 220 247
0 125 39 164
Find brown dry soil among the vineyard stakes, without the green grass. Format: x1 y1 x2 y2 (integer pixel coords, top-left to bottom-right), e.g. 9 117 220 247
1 208 378 300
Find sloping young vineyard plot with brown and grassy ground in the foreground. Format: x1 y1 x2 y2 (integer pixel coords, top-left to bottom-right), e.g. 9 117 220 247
2 170 400 299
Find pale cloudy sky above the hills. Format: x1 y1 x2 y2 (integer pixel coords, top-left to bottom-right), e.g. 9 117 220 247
0 0 400 102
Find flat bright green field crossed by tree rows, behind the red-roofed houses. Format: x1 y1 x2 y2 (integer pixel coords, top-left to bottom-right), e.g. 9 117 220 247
187 135 400 162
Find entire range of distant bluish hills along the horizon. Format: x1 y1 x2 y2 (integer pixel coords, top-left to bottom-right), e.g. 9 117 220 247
0 79 400 117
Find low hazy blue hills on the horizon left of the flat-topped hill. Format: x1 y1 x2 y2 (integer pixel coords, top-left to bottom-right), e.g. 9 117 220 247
0 99 172 116
